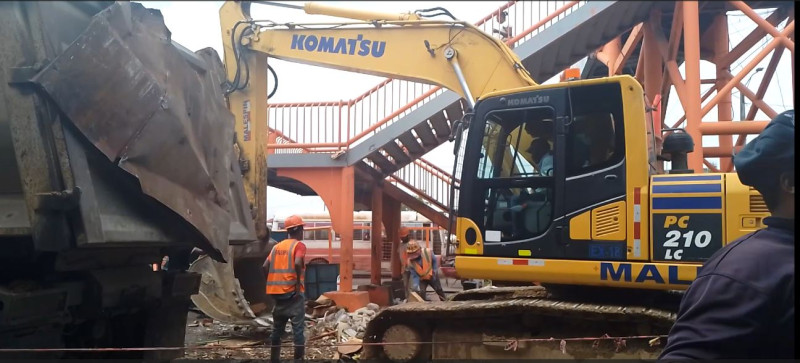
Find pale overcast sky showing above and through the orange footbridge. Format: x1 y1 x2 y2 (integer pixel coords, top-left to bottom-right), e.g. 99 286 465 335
141 1 794 217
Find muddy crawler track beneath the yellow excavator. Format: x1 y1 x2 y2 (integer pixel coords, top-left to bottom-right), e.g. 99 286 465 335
362 286 679 362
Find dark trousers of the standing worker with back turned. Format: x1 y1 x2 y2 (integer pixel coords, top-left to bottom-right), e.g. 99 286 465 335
270 294 306 362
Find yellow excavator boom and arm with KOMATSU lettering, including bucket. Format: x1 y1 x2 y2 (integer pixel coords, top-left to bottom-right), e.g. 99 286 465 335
192 1 536 323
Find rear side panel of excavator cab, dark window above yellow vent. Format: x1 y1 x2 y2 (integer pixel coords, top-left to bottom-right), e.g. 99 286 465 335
556 83 627 260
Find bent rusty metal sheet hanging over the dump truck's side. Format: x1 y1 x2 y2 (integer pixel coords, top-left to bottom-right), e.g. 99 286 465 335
29 2 245 260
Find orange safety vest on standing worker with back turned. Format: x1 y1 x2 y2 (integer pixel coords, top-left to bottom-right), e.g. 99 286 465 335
267 239 306 295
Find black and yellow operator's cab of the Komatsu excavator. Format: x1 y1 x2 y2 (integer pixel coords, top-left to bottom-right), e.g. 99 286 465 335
456 76 648 267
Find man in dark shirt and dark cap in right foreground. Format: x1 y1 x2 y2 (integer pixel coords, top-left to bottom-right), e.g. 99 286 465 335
659 110 796 359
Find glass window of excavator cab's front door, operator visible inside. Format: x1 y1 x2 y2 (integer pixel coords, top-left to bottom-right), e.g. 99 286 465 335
478 107 555 243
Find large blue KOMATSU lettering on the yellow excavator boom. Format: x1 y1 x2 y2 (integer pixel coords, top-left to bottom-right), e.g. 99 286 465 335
292 34 386 58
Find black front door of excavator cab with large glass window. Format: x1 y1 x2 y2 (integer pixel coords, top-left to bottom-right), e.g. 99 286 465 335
458 88 568 258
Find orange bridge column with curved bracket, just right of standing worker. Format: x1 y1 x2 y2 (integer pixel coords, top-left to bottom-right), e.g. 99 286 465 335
278 166 355 292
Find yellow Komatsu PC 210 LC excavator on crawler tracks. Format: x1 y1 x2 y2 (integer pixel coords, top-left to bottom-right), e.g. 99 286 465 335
200 2 768 361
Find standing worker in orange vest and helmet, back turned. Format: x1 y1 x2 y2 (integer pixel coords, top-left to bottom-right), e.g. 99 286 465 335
263 215 306 362
